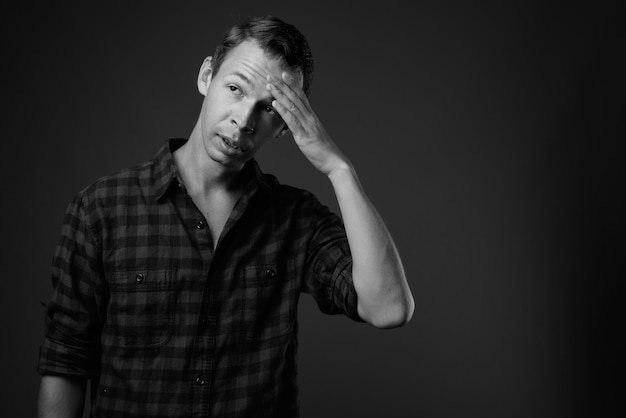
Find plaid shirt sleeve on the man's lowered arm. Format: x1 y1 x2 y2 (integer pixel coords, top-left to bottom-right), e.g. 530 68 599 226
37 194 103 377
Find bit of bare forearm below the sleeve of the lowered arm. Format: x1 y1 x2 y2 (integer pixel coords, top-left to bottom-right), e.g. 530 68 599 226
38 376 87 418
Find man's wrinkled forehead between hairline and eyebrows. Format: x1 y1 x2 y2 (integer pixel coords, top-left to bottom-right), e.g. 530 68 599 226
219 40 302 84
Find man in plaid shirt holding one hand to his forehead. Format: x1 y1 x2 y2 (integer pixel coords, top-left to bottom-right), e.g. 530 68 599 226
38 17 414 417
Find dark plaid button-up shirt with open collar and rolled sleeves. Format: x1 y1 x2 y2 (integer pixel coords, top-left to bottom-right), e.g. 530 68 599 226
37 140 359 417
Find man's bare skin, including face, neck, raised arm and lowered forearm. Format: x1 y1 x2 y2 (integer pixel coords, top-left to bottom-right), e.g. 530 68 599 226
39 37 415 417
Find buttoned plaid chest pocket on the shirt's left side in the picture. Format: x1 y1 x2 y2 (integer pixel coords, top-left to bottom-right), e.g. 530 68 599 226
105 270 175 348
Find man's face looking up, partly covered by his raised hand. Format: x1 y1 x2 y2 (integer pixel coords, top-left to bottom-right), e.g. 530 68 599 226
198 41 300 170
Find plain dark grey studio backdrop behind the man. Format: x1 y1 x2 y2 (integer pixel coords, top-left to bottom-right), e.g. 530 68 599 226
0 1 616 417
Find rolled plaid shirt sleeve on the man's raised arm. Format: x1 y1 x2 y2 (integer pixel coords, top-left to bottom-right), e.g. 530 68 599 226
304 200 363 322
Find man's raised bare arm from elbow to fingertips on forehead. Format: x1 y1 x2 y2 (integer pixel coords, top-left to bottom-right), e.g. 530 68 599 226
268 73 415 328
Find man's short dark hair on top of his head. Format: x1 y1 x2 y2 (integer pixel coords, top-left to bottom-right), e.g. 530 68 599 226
213 16 313 96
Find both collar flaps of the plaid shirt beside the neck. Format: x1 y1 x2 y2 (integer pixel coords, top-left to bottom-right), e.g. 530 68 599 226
153 138 272 201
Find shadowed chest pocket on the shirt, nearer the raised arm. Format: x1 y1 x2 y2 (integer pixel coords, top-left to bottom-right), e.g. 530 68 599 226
241 263 297 341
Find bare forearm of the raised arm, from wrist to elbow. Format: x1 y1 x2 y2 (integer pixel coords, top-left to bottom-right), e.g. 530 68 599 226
329 163 415 328
